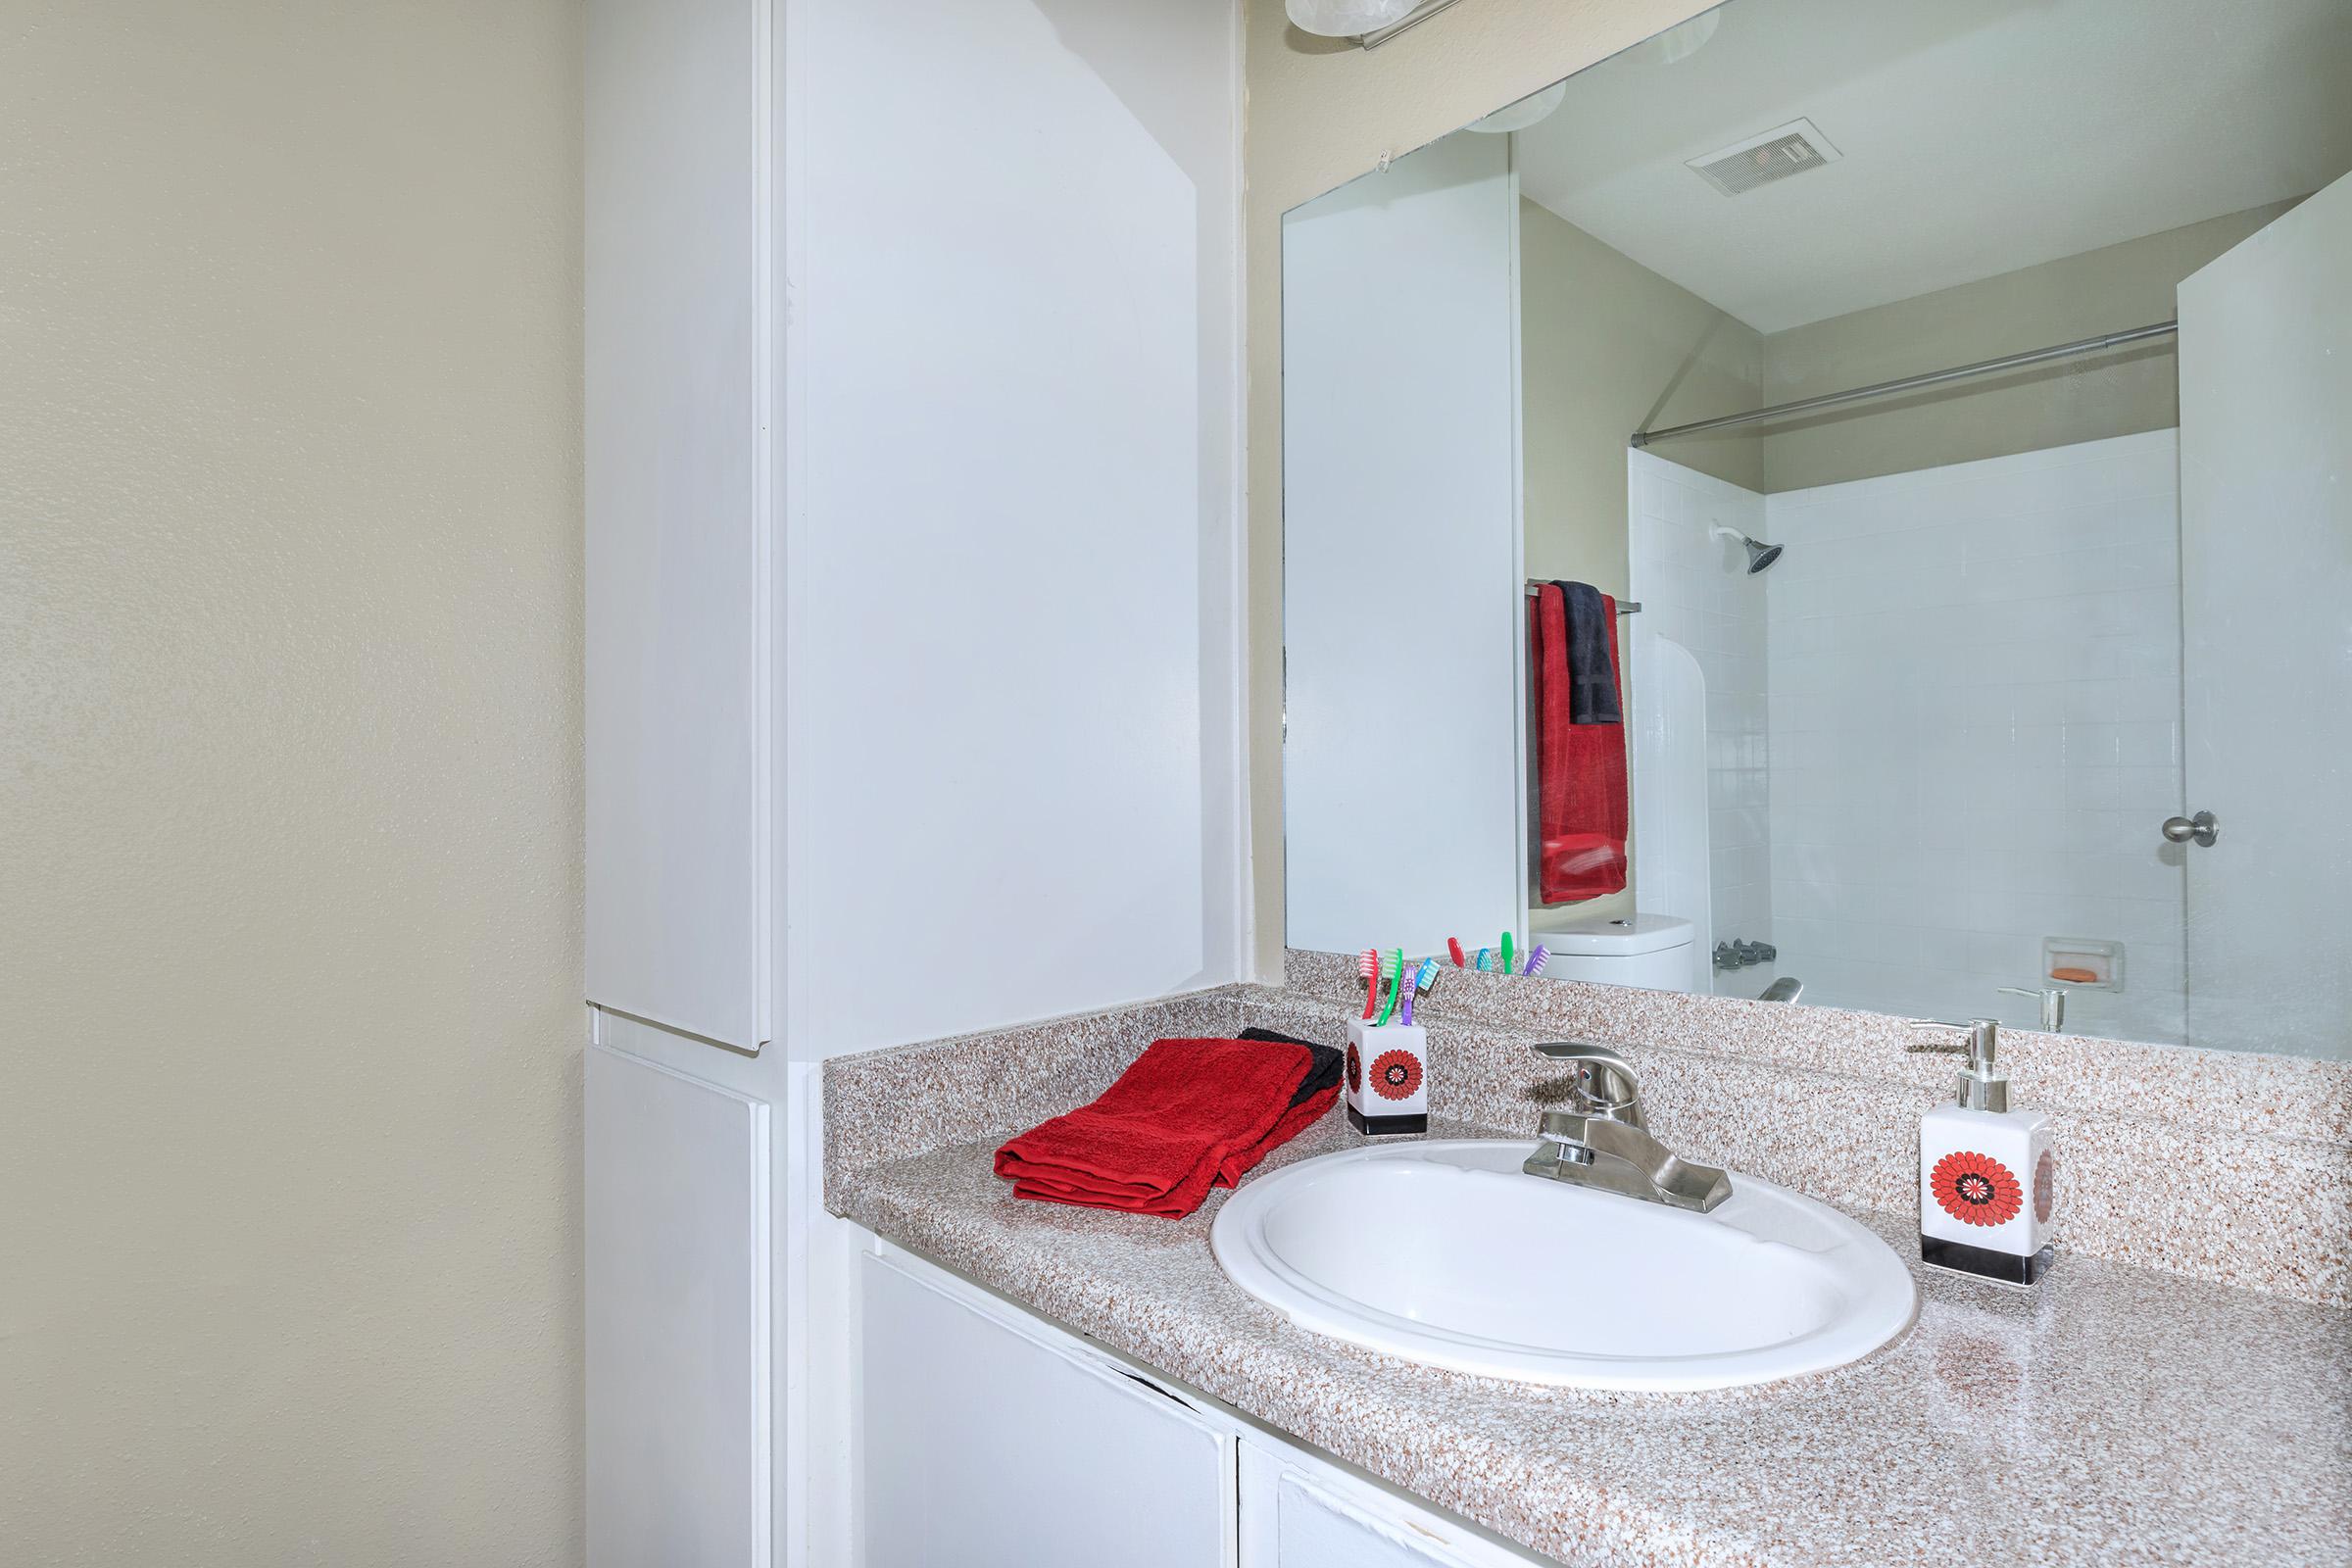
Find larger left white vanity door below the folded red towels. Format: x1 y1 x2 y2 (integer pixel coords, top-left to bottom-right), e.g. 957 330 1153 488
858 1255 1235 1568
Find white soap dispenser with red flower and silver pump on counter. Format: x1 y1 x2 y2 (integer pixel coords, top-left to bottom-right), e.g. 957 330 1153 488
1917 1018 2058 1286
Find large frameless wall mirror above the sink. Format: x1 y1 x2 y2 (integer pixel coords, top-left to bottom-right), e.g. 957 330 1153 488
1282 0 2352 1057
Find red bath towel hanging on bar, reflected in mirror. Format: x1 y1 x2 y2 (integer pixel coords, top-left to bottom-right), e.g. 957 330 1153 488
1527 583 1630 903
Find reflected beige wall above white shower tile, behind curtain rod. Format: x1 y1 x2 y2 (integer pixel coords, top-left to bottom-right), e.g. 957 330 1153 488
1759 202 2293 491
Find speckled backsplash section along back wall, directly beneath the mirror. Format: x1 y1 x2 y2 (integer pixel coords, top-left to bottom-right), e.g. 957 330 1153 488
1279 950 2352 1307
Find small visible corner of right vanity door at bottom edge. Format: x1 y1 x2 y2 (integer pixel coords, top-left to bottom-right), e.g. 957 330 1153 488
1240 1441 1541 1568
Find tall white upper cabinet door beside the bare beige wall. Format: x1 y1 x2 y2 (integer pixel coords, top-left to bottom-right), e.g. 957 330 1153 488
583 0 774 1051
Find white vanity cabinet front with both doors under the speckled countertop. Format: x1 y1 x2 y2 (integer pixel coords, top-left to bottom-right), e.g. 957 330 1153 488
858 1246 1543 1568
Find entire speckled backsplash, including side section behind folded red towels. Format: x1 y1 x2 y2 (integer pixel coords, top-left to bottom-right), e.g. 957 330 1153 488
825 950 2352 1307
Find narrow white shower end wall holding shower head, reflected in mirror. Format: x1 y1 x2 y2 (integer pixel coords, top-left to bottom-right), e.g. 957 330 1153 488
1628 452 1774 995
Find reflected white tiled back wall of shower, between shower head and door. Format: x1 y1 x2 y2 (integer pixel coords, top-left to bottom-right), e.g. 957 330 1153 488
1764 430 2182 1042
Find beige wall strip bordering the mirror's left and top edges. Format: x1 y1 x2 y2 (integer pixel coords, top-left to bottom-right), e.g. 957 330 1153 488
1242 0 1707 976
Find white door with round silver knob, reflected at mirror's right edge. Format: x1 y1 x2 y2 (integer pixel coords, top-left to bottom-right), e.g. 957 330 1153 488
2147 176 2352 1057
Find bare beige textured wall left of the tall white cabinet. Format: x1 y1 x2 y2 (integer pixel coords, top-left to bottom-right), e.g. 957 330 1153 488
0 0 581 1568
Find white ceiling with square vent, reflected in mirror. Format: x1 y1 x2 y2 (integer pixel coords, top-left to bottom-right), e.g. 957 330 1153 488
1517 0 2352 331
